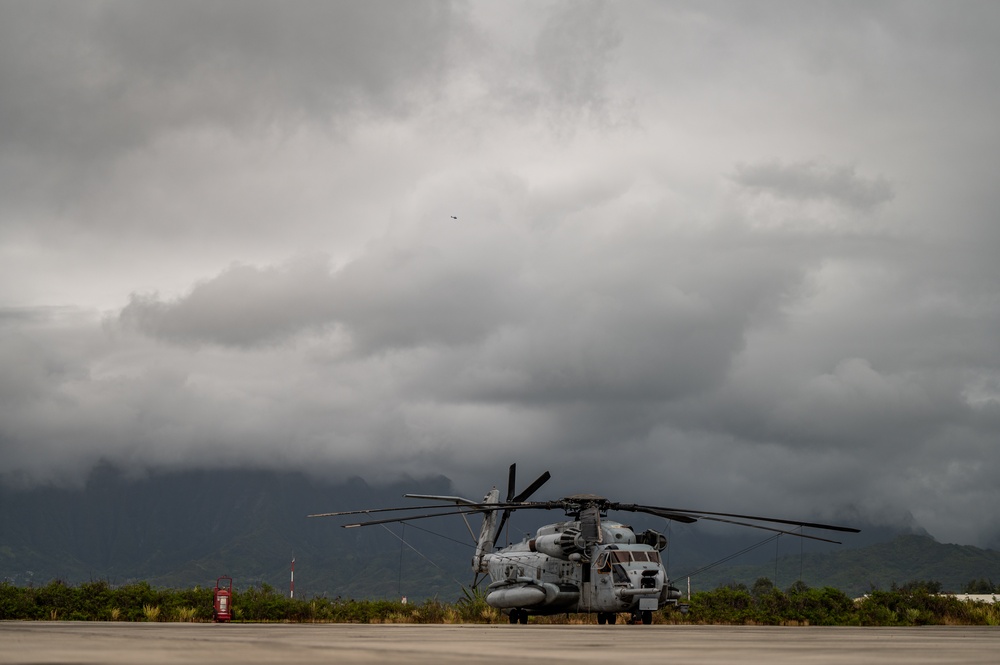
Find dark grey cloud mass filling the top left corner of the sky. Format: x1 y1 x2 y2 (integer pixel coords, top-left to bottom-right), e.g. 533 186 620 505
0 0 462 210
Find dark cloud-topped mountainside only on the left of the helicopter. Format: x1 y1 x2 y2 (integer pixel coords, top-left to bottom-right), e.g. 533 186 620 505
0 469 472 600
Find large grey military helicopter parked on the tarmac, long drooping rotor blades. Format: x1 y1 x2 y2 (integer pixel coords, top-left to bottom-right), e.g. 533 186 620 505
309 464 859 625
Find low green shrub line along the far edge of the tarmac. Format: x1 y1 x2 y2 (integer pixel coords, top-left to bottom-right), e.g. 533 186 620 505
0 578 1000 626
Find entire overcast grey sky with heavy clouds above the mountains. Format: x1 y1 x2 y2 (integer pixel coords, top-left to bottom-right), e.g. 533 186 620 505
0 0 1000 546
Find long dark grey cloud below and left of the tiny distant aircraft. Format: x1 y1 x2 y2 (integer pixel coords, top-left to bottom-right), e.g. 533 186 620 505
119 240 520 353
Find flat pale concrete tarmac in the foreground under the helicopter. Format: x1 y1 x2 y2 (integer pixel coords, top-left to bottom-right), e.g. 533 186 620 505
0 621 1000 665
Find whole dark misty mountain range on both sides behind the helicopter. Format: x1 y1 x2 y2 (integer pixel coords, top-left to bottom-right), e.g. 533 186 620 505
0 466 1000 601
